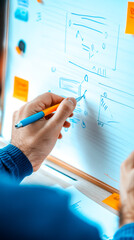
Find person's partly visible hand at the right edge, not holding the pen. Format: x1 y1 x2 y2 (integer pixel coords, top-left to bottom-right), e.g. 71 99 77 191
120 152 134 227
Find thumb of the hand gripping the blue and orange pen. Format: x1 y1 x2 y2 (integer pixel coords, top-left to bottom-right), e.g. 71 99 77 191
51 98 76 126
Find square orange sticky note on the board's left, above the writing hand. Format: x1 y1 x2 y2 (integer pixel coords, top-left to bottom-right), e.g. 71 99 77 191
13 77 29 102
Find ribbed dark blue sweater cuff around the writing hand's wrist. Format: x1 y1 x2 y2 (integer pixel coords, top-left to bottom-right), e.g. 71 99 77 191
0 144 33 182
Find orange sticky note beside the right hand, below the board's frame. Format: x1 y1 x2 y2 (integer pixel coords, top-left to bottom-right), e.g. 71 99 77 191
102 193 120 211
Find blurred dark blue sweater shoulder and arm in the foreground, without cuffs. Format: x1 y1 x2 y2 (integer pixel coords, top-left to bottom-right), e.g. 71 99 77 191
0 180 100 240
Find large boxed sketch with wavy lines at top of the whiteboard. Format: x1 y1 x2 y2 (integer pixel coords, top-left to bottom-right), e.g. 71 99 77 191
65 13 120 75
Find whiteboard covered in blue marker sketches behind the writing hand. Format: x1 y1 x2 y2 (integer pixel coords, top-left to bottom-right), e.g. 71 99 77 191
2 0 134 189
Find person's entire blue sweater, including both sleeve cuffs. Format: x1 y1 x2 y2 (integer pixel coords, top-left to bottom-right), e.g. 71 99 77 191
0 144 134 240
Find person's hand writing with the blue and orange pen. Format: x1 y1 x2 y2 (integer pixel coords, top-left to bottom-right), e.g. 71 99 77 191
11 93 76 171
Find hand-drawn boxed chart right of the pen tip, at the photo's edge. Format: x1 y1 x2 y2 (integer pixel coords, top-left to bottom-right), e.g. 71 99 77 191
98 92 134 129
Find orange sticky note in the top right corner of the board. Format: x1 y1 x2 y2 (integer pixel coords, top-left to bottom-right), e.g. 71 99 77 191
125 2 134 34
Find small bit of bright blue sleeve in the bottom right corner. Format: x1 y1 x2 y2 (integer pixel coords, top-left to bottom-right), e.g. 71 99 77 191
114 223 134 240
